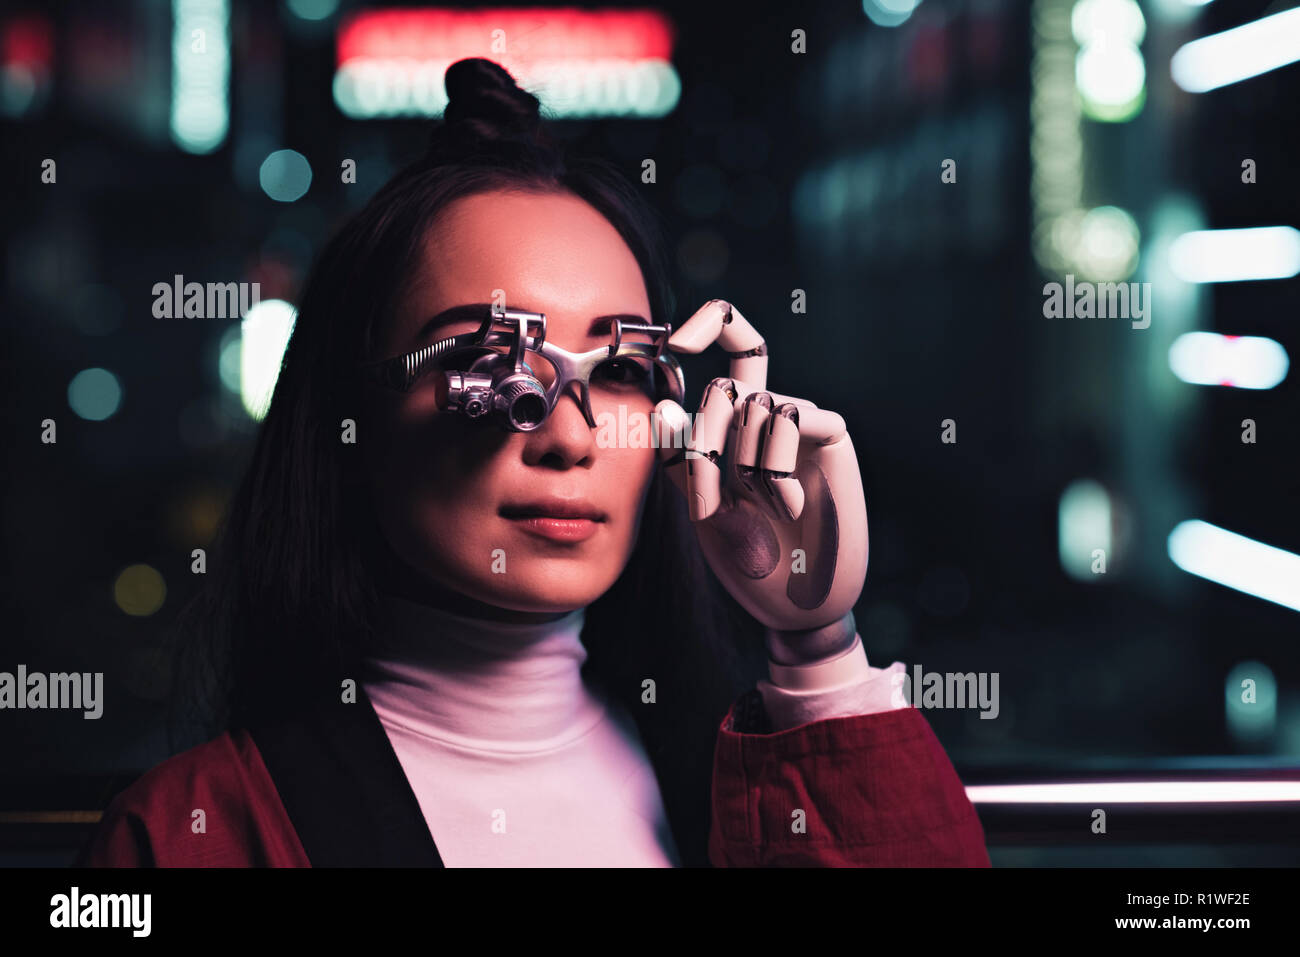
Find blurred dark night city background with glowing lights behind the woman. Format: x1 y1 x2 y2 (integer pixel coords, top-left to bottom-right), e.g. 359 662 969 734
0 0 1300 865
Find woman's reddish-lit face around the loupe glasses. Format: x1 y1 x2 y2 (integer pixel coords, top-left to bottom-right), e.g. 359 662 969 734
358 191 655 619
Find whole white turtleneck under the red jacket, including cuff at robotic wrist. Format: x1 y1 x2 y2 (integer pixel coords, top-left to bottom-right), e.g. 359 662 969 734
361 597 904 867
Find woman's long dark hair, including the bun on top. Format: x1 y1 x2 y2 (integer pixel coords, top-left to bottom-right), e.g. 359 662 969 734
172 59 762 865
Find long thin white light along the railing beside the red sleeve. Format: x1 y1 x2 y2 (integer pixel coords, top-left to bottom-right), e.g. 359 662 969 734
966 781 1300 805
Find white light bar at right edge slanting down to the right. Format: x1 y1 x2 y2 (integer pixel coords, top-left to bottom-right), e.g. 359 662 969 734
1169 519 1300 611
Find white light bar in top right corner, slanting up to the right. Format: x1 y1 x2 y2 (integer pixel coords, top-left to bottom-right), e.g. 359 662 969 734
1169 7 1300 94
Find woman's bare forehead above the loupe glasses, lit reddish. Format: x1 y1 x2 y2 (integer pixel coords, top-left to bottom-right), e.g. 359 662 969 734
389 192 650 350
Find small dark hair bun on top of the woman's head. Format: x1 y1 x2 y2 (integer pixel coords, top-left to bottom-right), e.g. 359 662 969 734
429 57 542 153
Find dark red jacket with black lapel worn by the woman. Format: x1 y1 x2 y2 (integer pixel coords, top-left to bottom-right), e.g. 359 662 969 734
78 692 989 867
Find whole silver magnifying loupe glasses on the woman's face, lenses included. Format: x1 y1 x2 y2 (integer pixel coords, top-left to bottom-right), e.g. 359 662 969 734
361 308 686 432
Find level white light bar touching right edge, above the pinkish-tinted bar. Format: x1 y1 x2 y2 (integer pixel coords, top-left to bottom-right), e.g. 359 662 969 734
1169 226 1300 282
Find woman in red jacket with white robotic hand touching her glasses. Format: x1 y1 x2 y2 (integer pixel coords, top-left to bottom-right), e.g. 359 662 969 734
82 60 988 866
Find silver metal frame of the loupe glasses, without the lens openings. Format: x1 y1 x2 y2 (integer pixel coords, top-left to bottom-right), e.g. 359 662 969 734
361 308 686 432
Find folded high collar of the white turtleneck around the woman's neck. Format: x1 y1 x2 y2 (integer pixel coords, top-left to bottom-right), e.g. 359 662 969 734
363 596 605 754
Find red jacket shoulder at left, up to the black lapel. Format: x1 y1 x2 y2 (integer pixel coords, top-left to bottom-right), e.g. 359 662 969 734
79 731 306 867
